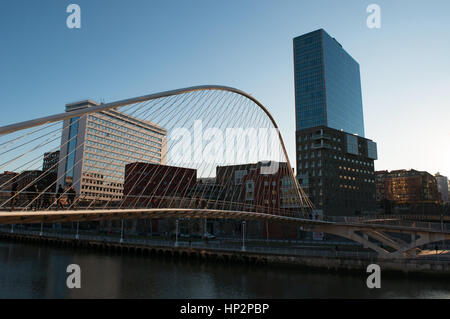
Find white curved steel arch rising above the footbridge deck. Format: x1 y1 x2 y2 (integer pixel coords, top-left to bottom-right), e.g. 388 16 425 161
0 85 313 208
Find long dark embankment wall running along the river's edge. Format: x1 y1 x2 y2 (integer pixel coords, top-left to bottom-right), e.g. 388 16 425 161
0 233 450 277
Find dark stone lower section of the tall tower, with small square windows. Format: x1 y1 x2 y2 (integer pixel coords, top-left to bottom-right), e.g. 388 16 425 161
297 126 377 216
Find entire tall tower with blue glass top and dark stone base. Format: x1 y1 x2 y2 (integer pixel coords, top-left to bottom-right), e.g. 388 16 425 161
293 29 377 215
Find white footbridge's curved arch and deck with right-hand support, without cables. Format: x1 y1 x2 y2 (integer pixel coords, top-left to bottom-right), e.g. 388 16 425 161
0 85 450 258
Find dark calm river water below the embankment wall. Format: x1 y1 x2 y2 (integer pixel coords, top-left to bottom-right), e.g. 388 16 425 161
0 241 450 299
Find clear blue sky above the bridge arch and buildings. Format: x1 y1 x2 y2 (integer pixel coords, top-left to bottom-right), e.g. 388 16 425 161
0 0 450 175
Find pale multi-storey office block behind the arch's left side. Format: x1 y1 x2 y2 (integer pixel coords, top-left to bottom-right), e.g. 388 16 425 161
58 100 167 200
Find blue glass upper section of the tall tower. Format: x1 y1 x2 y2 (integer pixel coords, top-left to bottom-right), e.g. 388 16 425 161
294 29 364 137
